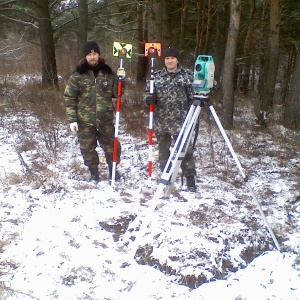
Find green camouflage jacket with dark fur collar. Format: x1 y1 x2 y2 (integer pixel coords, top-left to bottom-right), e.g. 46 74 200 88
64 62 117 127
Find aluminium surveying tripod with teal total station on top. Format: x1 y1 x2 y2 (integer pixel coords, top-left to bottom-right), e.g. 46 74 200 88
127 55 280 262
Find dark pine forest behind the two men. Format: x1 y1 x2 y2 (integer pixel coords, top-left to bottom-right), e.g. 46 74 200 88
0 0 300 130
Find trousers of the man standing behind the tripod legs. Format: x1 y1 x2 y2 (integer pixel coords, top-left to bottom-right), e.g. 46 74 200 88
157 133 196 177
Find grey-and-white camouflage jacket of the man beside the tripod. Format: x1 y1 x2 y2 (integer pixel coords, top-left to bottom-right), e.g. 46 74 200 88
148 65 194 135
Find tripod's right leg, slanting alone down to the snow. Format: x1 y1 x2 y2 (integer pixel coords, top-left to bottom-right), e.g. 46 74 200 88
209 103 280 251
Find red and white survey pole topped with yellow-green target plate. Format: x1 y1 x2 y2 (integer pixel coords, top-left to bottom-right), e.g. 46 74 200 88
111 42 132 187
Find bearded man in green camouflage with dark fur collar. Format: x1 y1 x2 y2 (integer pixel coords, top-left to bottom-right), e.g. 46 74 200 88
64 41 125 181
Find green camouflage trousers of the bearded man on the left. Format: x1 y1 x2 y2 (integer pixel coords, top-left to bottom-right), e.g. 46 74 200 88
77 124 121 169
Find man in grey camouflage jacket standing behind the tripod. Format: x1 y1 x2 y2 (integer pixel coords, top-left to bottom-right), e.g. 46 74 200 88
145 48 196 191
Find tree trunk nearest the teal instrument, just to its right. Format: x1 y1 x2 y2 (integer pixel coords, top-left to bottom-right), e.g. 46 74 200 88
222 0 241 129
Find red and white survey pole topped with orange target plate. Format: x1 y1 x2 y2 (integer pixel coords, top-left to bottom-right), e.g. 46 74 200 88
145 43 161 180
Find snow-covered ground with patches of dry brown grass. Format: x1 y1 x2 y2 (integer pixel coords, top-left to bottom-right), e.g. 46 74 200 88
0 92 300 300
